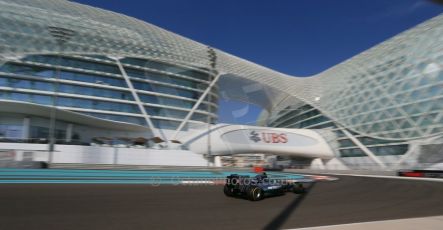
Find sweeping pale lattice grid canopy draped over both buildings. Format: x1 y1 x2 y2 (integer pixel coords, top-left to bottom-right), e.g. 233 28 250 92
0 0 443 144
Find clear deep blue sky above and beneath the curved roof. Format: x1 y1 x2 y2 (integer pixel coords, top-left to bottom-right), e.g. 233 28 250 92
76 0 443 126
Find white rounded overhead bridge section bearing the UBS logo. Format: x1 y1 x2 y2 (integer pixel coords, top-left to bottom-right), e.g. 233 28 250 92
179 124 335 160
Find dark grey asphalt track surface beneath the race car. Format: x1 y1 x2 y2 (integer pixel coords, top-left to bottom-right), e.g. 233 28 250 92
0 176 443 230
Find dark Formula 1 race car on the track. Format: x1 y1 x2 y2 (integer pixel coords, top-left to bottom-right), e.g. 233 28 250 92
223 173 306 201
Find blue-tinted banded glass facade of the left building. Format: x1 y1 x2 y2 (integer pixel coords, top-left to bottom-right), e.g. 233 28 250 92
0 55 218 129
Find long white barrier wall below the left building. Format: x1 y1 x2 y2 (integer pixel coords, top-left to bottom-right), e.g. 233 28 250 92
0 143 208 166
